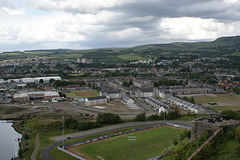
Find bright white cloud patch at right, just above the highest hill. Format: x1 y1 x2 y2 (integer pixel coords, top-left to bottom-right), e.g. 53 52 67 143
159 17 240 41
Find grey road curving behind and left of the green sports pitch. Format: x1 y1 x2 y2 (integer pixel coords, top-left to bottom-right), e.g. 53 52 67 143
41 120 191 160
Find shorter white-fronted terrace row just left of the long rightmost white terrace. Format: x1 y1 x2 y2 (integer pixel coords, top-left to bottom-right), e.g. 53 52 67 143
145 97 171 113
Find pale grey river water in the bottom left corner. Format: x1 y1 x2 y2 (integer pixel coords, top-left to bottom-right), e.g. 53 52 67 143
0 121 22 160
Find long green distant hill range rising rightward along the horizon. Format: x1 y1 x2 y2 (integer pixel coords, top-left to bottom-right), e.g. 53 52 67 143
0 36 240 63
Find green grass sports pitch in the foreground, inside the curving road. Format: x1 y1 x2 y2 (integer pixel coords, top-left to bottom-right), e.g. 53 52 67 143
72 127 182 160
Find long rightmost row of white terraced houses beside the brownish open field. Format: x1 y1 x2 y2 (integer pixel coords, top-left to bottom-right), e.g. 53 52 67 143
167 96 205 114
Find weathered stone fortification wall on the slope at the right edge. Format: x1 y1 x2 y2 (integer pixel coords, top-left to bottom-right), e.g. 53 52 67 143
191 117 240 141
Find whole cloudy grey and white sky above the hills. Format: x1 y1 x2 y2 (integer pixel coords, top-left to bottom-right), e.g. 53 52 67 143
0 0 240 52
